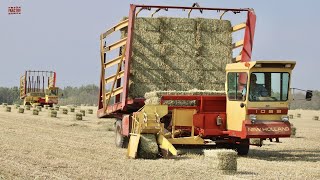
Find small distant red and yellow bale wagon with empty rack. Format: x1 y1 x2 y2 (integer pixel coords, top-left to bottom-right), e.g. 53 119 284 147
20 71 59 107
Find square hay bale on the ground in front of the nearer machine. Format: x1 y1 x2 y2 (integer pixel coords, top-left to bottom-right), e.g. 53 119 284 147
204 149 238 173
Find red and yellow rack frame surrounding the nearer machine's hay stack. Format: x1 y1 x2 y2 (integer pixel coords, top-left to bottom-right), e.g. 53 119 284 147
97 4 256 118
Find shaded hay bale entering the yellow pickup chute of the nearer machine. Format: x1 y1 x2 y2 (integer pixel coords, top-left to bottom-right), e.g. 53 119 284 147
138 134 159 159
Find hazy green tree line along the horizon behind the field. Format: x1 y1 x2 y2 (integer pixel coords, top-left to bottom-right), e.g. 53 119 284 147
0 84 320 110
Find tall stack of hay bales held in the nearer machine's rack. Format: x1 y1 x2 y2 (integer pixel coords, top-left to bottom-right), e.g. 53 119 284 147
122 17 232 98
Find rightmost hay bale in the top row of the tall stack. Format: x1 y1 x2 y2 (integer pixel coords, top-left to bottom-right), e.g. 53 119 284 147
196 18 232 33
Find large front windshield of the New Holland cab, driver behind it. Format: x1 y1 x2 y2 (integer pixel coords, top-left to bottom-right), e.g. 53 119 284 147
249 72 289 101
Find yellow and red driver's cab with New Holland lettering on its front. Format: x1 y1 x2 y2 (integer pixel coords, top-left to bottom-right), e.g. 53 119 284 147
226 61 296 138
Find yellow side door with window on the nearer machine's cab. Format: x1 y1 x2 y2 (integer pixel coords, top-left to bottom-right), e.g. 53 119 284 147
226 72 248 131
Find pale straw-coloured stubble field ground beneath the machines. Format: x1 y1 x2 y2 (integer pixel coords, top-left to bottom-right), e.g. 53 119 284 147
0 107 320 179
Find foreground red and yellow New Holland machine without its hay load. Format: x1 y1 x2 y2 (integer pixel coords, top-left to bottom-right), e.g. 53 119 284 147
97 5 310 158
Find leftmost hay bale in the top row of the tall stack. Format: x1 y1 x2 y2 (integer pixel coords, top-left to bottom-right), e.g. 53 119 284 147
134 17 161 32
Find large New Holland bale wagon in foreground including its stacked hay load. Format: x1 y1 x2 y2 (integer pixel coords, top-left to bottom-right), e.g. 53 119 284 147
97 3 295 157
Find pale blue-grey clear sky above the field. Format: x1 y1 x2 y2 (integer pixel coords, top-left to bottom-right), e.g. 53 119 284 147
0 0 320 89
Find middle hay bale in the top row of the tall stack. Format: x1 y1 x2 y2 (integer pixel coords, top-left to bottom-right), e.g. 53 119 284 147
158 17 197 32
